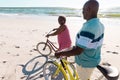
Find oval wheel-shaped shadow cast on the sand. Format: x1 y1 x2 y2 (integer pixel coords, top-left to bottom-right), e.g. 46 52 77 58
22 55 48 75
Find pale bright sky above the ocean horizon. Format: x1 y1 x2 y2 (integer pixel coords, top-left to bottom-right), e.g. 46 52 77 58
0 0 120 9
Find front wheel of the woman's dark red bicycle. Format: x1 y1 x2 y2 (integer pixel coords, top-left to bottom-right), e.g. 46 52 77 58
36 42 52 56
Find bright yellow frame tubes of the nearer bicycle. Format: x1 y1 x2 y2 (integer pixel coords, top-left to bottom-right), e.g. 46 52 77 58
52 59 79 80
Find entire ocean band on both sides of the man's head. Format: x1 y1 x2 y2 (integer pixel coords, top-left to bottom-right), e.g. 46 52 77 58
0 7 120 17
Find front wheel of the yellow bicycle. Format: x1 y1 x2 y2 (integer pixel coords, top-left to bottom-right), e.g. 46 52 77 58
43 61 66 80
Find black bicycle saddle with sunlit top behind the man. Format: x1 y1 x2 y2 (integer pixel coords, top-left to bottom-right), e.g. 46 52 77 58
97 65 119 80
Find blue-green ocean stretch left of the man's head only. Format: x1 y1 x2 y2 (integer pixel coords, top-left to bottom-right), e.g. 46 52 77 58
0 7 81 16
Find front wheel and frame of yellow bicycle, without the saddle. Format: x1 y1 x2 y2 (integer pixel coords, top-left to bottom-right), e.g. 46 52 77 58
43 58 80 80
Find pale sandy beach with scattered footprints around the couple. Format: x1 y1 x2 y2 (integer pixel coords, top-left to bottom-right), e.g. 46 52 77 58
0 15 120 80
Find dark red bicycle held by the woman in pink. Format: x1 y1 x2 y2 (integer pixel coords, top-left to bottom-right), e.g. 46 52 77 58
36 30 58 56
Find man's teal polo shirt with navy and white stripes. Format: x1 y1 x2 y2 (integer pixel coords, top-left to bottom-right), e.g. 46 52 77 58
75 18 104 68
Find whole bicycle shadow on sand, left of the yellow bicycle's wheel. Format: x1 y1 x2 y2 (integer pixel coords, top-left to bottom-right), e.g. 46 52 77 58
20 55 48 80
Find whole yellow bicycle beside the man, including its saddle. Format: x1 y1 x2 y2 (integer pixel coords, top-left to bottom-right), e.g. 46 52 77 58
43 58 119 80
